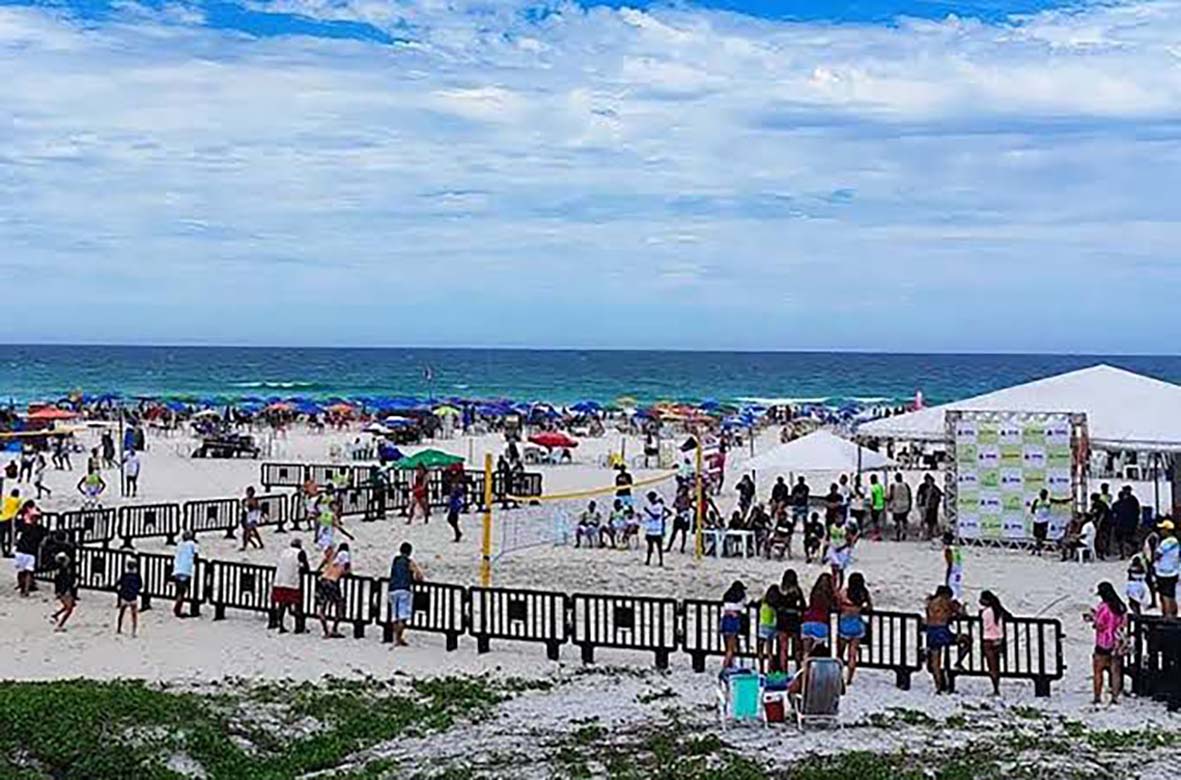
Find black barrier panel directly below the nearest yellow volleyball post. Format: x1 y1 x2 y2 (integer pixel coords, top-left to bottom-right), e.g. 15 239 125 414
468 587 569 661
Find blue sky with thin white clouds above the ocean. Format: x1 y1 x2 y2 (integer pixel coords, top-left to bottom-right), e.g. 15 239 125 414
0 0 1181 353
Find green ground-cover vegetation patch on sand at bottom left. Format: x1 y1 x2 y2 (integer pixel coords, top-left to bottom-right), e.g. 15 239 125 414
0 677 526 780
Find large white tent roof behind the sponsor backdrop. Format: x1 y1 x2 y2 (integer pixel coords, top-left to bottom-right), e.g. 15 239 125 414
857 365 1181 451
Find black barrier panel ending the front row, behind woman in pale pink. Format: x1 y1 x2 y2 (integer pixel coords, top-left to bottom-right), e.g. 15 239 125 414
944 616 1066 696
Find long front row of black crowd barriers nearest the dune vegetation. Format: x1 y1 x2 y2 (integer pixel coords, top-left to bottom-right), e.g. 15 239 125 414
25 541 1072 706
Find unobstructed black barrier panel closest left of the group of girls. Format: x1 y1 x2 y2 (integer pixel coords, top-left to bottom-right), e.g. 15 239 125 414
570 593 678 669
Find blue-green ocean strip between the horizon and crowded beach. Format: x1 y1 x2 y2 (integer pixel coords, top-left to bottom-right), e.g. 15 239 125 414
0 345 1181 403
